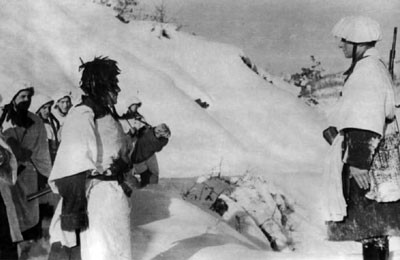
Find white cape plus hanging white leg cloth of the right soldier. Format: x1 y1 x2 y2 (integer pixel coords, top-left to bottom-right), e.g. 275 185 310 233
324 48 395 221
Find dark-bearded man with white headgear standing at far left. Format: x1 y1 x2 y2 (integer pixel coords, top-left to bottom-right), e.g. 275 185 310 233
0 82 51 245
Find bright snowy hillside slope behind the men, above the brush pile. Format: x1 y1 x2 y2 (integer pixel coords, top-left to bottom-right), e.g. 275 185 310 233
0 0 325 181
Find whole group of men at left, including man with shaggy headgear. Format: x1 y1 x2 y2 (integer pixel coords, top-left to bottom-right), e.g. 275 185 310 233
0 57 170 260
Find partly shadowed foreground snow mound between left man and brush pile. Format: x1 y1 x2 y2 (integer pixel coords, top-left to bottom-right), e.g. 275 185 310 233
131 186 260 259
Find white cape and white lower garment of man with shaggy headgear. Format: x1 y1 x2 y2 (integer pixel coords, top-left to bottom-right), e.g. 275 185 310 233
49 106 132 260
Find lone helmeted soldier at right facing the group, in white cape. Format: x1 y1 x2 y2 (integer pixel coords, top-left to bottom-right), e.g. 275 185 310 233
325 16 400 259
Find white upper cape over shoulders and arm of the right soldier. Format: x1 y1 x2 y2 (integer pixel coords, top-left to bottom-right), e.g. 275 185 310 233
332 48 395 136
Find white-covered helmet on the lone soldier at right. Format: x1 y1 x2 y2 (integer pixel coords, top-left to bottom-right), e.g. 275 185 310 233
332 16 382 43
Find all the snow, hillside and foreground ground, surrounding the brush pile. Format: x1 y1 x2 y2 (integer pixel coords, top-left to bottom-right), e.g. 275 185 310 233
0 0 399 260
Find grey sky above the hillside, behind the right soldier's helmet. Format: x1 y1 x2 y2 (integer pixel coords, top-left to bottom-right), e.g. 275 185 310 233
144 0 400 73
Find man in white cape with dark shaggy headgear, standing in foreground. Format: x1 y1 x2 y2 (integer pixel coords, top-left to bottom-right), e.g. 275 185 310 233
49 57 132 260
